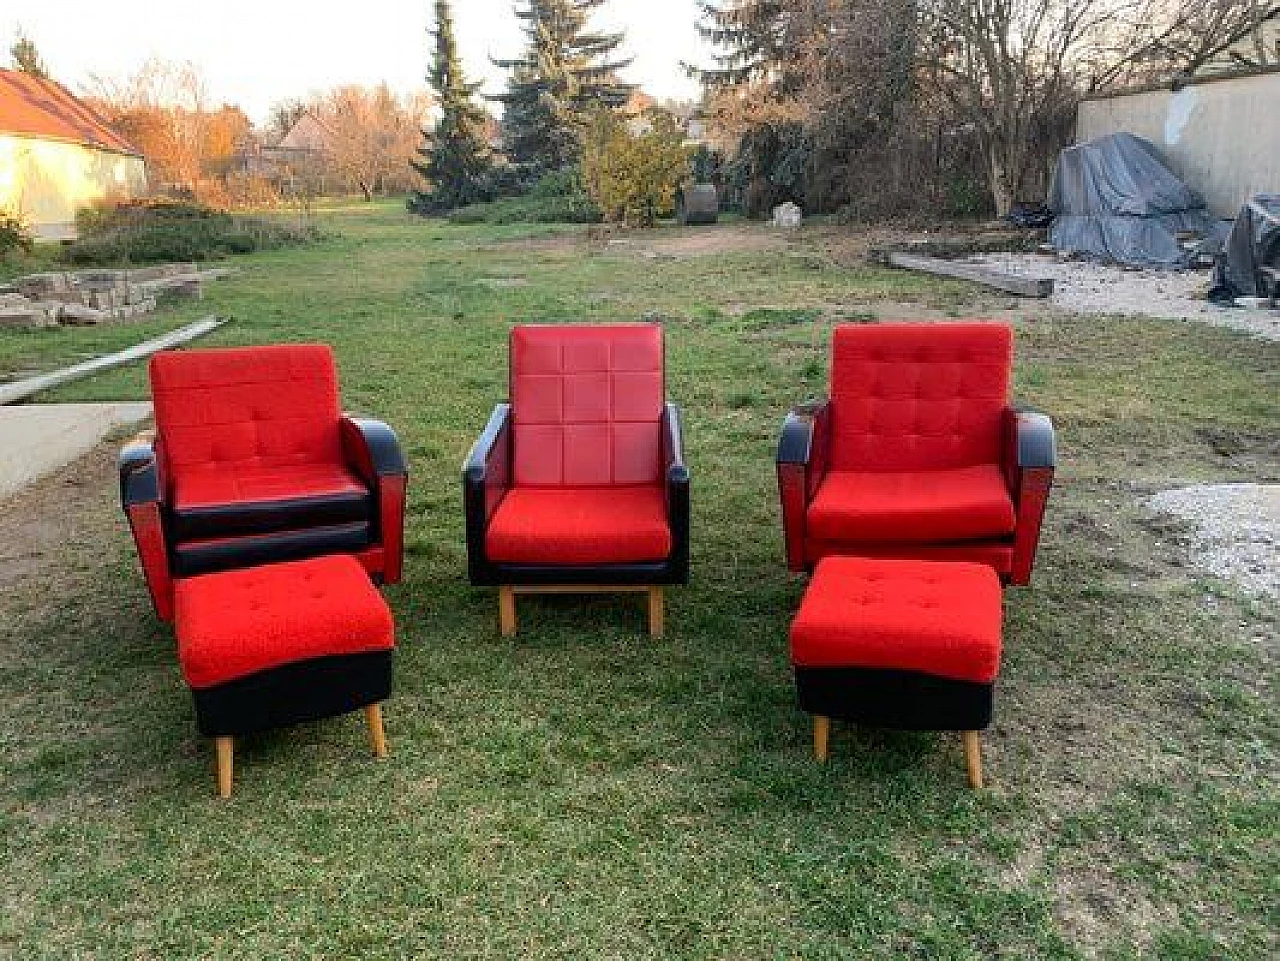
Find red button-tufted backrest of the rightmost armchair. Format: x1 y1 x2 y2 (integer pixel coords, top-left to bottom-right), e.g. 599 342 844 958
831 322 1014 471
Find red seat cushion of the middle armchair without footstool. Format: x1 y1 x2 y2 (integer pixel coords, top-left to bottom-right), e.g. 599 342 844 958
485 486 671 564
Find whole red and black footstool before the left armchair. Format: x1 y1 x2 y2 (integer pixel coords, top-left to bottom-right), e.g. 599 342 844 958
174 555 396 797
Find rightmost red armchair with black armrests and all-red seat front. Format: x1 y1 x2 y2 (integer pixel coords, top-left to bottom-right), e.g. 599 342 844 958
777 322 1056 584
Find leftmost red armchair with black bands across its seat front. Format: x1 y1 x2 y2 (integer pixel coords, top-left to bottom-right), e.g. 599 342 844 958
119 345 407 621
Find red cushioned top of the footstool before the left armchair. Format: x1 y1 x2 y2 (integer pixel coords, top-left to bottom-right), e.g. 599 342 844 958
174 557 396 688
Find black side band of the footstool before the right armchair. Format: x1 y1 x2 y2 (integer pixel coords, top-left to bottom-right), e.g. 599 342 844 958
795 667 996 731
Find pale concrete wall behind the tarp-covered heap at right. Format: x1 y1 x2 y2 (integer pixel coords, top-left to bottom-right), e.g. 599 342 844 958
1076 73 1280 216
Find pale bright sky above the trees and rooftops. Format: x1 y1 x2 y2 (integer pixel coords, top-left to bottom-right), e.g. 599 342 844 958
0 0 709 122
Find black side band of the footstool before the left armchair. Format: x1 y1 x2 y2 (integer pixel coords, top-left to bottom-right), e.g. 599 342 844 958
191 650 392 737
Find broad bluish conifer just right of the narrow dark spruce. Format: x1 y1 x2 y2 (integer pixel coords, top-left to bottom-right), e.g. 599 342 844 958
494 0 632 179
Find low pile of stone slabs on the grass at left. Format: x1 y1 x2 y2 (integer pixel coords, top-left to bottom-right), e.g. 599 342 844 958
0 264 234 328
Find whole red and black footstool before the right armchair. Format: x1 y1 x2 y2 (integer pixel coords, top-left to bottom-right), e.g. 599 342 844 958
791 557 1002 787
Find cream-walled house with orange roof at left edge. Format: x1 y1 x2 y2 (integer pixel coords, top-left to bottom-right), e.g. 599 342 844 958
0 69 147 238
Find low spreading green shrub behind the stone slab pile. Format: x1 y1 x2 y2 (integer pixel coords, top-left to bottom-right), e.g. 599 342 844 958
61 201 320 266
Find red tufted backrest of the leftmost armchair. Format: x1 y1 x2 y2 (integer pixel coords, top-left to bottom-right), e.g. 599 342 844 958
150 344 342 473
